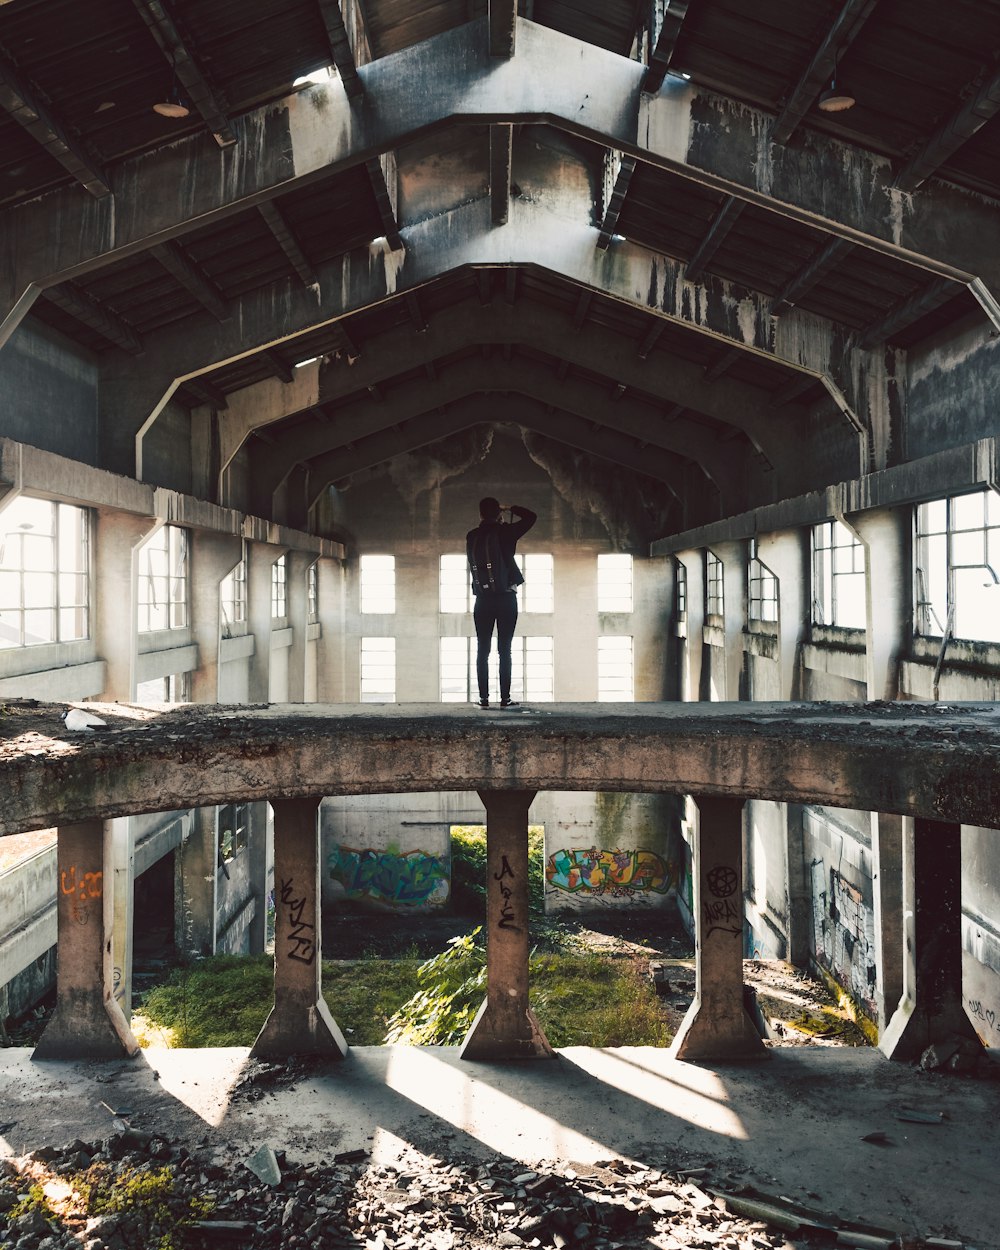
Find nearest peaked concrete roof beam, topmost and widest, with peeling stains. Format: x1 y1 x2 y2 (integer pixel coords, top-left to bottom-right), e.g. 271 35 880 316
0 19 1000 339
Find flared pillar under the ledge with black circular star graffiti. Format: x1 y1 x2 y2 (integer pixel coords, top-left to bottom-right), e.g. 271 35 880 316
670 795 768 1060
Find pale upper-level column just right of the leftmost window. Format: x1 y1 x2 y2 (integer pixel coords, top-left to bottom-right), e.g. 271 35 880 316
94 509 160 703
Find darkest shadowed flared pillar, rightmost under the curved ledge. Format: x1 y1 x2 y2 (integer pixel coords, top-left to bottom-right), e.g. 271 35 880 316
879 819 983 1063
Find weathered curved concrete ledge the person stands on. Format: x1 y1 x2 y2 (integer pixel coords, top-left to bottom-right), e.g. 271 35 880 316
0 703 1000 834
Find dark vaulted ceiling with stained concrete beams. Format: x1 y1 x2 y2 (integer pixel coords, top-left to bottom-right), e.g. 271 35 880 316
0 0 1000 527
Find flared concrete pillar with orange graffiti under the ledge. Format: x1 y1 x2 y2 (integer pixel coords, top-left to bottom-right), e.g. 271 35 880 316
31 820 139 1059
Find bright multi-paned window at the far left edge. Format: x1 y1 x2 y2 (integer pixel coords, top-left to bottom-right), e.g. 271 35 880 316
0 495 90 648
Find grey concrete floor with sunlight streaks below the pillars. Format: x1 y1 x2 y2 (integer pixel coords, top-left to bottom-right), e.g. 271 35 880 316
0 1046 1000 1250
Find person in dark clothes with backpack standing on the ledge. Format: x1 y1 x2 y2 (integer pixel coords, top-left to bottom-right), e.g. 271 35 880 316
465 495 538 708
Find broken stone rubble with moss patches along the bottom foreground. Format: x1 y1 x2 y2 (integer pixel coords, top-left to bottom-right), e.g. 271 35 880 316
0 1128 961 1250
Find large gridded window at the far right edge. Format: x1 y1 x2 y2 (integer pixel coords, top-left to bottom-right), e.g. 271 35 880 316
914 490 1000 643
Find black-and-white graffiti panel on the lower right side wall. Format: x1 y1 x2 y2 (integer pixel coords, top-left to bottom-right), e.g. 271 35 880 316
813 860 879 1020
